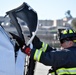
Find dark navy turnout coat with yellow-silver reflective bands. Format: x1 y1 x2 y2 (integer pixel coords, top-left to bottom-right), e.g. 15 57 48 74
31 42 76 75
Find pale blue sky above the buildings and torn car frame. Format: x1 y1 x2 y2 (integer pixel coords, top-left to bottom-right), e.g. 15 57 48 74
0 0 76 19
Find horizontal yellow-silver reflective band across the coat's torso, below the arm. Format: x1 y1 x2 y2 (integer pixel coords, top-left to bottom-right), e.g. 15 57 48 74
56 68 76 75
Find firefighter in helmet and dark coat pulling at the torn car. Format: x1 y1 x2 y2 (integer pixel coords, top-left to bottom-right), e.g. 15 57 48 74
10 29 76 75
